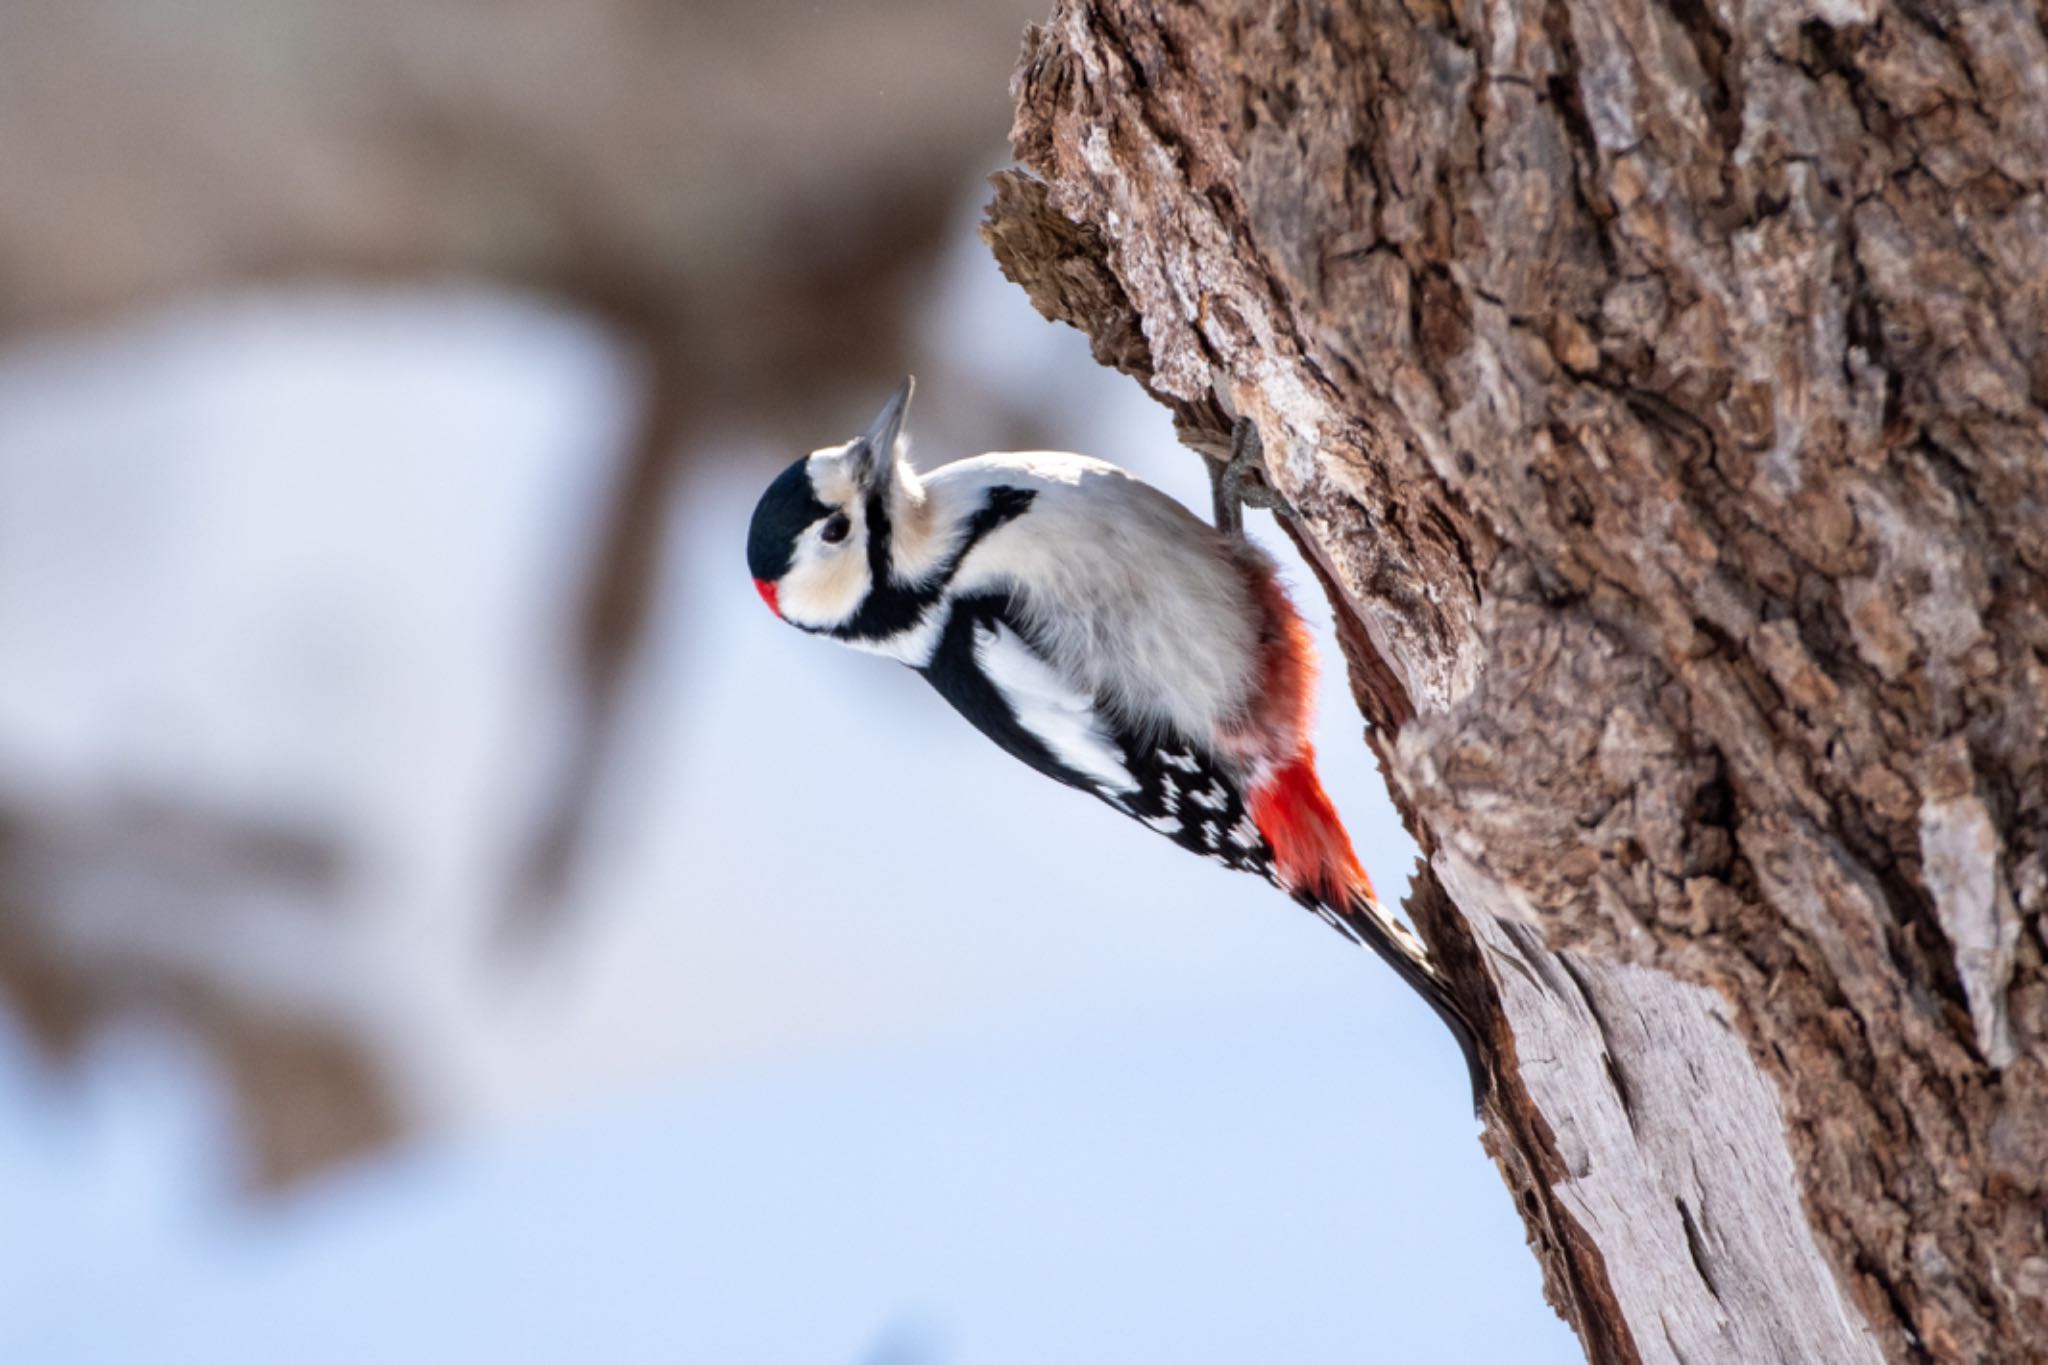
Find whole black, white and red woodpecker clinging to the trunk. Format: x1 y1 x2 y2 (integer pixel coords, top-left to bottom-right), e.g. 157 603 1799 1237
748 379 1487 1107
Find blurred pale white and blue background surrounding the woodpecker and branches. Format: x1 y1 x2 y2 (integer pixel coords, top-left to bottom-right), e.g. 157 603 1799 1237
0 197 1577 1363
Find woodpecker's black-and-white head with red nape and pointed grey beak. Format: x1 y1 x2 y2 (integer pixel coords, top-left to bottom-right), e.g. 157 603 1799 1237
748 379 915 630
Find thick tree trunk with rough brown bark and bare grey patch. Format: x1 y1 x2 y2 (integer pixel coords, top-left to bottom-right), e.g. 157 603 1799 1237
987 0 2048 1365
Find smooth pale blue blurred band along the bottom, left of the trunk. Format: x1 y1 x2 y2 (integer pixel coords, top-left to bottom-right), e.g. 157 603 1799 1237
0 990 1579 1365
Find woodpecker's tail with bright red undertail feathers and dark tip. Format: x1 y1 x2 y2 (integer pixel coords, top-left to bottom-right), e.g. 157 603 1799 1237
1251 747 1491 1111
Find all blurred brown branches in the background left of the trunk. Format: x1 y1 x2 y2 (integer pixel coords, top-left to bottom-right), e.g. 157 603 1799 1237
0 0 1038 1181
